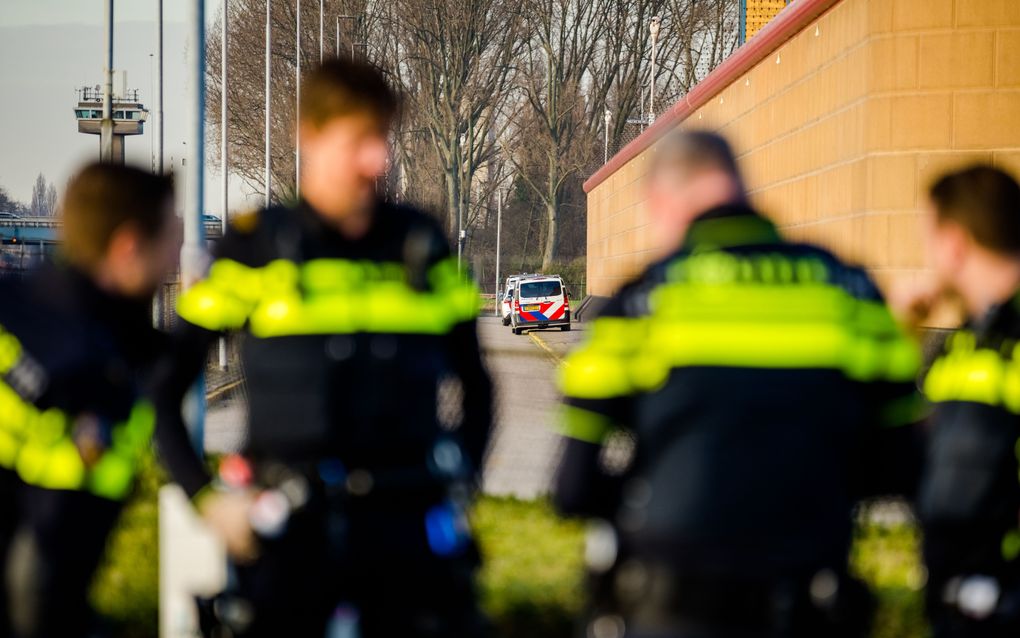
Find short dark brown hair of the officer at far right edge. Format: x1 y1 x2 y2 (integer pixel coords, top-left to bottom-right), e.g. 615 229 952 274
929 164 1020 256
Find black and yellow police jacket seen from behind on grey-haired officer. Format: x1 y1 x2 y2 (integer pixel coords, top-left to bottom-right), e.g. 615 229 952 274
555 205 922 582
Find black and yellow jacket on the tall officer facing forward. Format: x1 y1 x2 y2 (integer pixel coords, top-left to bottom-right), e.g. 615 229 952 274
159 203 491 498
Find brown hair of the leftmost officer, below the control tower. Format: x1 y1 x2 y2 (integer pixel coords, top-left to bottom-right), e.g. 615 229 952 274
60 162 173 267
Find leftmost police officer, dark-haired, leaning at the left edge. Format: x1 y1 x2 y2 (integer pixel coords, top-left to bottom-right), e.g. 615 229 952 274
0 164 180 638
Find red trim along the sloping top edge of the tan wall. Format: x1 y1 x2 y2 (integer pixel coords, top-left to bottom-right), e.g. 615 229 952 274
584 0 840 193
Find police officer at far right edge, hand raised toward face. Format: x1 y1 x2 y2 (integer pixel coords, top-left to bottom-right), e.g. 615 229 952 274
904 165 1020 638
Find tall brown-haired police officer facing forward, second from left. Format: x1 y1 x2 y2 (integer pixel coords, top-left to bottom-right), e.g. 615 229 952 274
158 55 491 638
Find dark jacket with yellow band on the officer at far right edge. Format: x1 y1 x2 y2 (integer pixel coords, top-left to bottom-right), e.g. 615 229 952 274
918 293 1020 596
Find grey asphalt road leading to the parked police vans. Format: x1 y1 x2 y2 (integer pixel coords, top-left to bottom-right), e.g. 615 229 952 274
205 316 583 498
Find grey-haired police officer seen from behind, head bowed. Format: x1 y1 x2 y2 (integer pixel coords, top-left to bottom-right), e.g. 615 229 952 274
555 132 919 638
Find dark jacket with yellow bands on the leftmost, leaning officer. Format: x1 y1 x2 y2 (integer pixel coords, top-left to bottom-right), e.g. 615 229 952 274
0 266 163 500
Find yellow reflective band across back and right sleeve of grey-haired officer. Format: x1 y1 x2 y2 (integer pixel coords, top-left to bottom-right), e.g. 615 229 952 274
640 279 920 389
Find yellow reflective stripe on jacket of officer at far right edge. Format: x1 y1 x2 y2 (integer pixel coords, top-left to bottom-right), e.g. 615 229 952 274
924 331 1020 414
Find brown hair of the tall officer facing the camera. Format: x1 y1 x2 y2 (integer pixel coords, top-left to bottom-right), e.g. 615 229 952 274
301 58 399 128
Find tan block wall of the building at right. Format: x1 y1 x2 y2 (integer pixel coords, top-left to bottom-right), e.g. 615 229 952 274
588 0 1020 295
